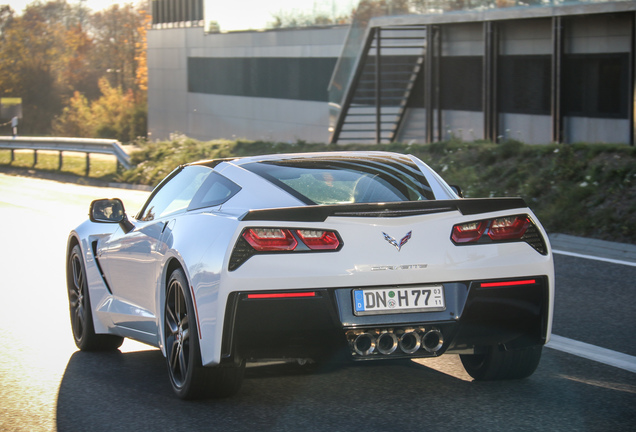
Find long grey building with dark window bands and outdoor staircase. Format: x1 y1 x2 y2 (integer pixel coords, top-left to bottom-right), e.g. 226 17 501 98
148 0 636 145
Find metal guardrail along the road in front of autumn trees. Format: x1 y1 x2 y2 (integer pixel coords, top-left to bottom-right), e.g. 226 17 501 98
0 136 132 175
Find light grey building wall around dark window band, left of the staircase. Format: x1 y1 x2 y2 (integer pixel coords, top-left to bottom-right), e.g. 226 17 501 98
148 27 348 142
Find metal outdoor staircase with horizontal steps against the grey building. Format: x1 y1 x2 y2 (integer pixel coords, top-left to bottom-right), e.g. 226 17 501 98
330 26 426 144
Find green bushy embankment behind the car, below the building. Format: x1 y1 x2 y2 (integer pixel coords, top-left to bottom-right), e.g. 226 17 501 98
119 140 636 243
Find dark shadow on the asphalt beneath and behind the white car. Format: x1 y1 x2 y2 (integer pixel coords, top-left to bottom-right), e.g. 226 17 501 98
56 350 634 432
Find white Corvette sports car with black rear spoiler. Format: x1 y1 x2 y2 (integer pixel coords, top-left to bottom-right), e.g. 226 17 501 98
67 152 554 399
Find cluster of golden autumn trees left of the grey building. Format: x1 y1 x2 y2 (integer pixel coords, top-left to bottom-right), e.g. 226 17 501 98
0 0 149 140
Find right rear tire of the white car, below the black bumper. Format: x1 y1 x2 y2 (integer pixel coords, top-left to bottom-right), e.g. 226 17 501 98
459 346 543 381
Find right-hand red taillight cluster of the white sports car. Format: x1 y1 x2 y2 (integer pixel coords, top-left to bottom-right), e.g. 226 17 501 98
451 215 547 255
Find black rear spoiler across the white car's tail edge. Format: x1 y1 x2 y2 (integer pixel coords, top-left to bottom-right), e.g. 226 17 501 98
239 198 528 222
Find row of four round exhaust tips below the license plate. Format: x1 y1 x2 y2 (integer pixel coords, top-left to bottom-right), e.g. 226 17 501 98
347 327 444 357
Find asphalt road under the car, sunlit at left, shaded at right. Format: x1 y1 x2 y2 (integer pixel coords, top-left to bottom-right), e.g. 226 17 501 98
0 174 636 432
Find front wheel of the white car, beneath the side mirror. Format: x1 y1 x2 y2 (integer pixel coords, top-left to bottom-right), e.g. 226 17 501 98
66 245 124 351
